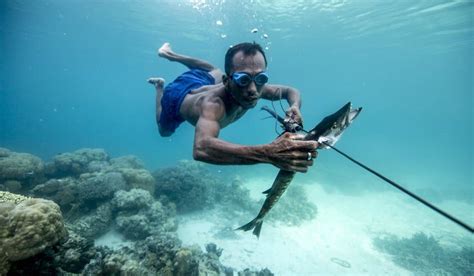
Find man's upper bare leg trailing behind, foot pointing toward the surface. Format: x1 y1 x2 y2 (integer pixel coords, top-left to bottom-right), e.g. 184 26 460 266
158 42 223 84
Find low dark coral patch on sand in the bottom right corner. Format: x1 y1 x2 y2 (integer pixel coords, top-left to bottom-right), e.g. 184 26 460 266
373 233 474 275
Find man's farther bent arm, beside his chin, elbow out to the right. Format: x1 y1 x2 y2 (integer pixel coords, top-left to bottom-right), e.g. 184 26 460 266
262 84 303 125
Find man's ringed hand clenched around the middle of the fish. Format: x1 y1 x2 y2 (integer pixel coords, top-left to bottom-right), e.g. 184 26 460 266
266 132 318 172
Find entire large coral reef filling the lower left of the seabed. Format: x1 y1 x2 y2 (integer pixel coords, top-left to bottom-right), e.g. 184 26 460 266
0 148 278 275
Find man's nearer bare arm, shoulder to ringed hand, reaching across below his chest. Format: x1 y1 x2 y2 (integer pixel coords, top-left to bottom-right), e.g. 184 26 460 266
193 99 318 172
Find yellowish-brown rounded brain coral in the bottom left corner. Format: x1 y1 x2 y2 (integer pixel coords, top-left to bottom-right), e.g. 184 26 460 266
0 192 67 275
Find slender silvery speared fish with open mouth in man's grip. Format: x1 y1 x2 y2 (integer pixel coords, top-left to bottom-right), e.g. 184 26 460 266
237 102 362 237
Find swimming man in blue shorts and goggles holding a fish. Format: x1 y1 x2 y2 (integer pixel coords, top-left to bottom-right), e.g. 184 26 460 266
148 43 318 172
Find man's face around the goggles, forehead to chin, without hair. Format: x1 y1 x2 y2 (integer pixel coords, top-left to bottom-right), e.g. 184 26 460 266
228 51 265 109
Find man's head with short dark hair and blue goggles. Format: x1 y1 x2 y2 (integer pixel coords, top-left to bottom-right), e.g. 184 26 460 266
224 42 268 109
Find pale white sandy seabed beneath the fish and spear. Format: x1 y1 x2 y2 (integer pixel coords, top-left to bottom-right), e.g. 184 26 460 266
178 178 474 275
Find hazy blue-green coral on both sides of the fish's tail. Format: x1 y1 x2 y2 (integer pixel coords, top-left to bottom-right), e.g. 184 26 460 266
153 161 317 225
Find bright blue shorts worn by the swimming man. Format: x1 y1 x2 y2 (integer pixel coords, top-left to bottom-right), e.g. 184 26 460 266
160 69 215 133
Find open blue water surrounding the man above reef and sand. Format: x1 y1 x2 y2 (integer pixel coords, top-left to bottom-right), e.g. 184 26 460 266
0 0 474 220
